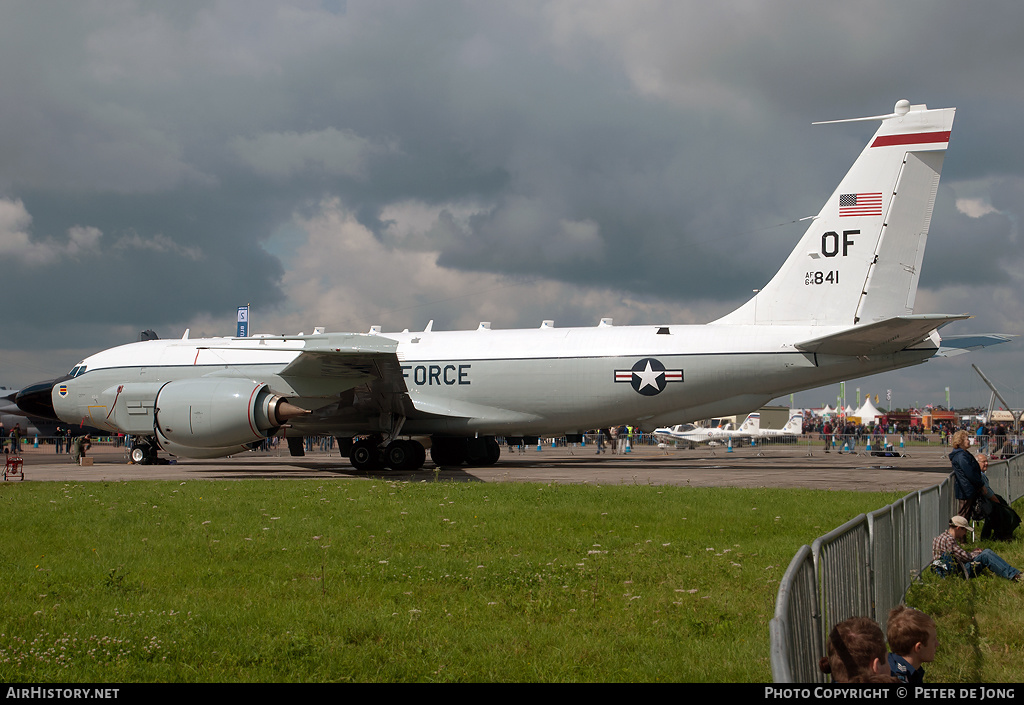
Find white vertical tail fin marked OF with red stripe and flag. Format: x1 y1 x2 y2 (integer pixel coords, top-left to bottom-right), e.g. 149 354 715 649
715 100 955 326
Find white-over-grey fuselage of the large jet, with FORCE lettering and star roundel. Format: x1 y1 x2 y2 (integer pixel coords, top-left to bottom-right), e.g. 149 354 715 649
52 325 936 436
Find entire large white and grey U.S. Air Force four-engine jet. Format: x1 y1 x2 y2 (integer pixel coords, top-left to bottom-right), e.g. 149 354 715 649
17 100 1007 470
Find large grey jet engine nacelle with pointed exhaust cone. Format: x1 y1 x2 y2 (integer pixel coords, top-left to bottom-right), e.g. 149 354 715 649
154 377 306 458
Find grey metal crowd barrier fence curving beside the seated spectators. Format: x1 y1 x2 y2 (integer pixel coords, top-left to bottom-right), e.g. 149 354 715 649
769 455 1024 682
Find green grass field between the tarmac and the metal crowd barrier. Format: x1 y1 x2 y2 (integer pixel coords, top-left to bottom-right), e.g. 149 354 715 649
0 481 1021 682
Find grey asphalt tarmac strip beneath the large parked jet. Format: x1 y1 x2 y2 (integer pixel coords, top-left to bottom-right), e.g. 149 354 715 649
4 441 950 492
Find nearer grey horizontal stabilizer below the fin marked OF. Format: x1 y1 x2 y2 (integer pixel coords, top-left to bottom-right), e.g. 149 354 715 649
796 314 971 356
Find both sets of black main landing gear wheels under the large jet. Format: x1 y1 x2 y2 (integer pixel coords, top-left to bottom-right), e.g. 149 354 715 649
348 436 501 472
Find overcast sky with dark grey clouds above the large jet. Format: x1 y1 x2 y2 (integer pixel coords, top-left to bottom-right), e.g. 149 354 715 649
0 0 1024 406
